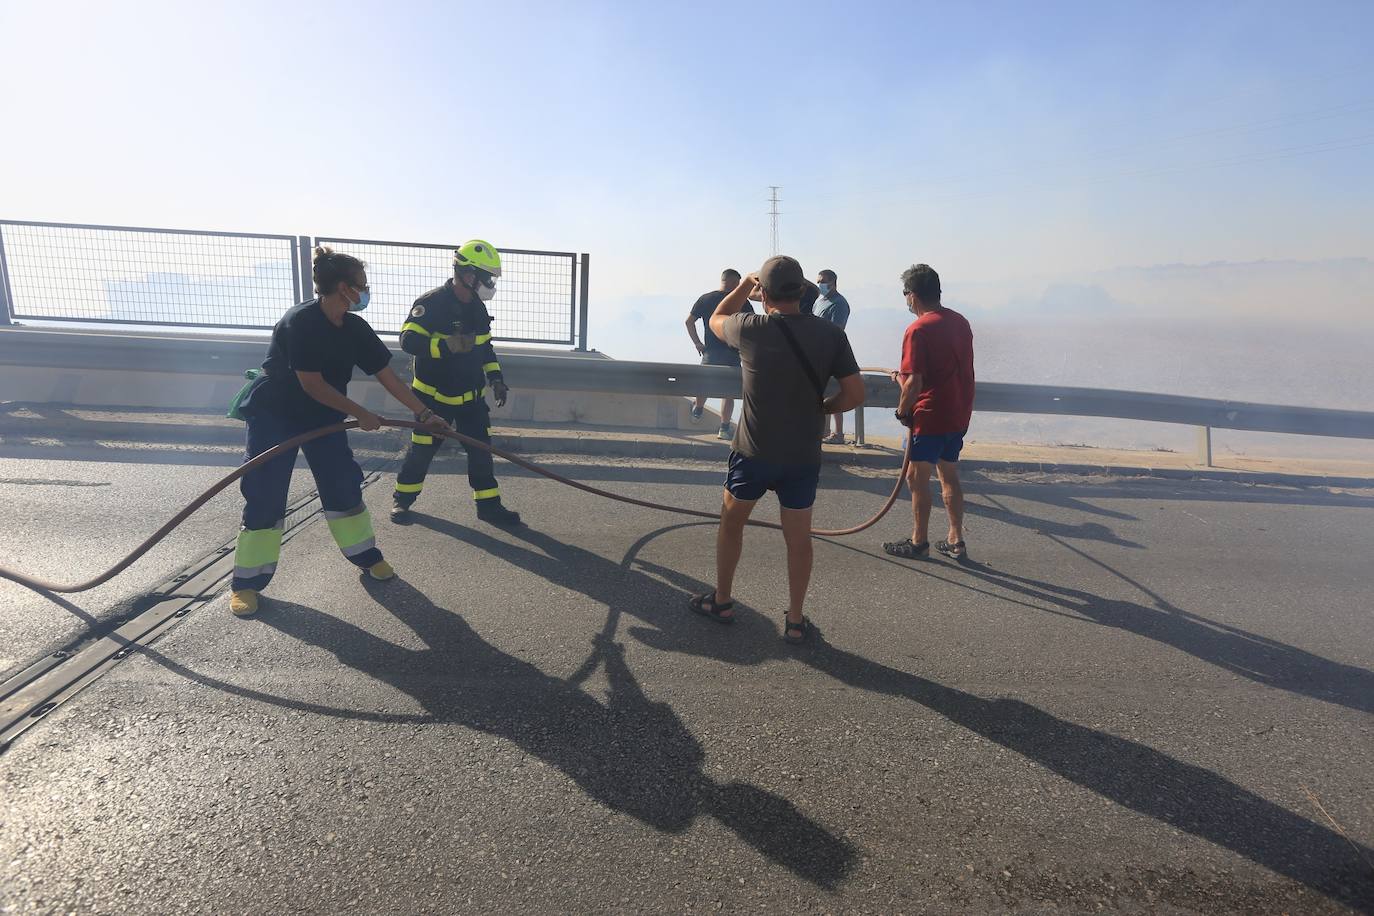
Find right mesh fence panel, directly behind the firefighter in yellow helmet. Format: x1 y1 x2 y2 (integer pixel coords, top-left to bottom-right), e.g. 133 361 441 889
315 238 577 343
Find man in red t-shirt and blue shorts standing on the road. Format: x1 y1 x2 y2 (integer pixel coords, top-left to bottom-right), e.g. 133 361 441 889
882 264 974 560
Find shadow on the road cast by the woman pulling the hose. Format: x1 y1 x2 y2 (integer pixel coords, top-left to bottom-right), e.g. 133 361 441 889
240 580 856 890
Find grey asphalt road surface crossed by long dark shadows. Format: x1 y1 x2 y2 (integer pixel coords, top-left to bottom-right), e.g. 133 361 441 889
0 439 1374 913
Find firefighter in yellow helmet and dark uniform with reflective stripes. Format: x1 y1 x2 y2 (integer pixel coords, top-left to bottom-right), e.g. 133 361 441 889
392 239 519 525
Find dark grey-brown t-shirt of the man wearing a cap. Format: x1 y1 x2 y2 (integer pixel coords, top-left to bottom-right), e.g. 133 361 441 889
723 314 859 464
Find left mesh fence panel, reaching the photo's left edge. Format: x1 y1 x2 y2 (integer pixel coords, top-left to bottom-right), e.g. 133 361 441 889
0 221 300 328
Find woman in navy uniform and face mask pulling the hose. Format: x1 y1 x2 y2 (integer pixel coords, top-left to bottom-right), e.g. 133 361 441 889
229 249 448 617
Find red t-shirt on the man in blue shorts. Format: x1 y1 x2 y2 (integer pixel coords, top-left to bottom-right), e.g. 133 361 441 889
901 308 973 435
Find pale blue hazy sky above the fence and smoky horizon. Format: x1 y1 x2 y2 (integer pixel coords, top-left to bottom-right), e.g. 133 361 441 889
0 0 1374 349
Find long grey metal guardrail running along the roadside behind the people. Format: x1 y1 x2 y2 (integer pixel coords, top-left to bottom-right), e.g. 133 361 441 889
0 328 1374 464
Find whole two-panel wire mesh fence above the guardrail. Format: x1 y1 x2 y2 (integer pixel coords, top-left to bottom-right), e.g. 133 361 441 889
0 220 589 350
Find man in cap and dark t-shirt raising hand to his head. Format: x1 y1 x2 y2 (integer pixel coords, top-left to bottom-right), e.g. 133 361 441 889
691 257 864 643
